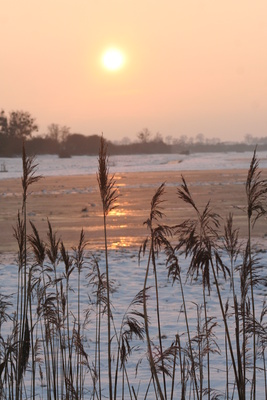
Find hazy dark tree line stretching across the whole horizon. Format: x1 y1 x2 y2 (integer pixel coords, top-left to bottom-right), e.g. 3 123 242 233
0 110 267 157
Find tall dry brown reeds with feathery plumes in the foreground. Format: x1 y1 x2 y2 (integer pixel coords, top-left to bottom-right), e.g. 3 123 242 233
0 142 267 400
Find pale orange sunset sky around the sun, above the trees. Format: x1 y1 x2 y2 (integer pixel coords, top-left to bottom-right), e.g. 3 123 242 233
0 0 267 141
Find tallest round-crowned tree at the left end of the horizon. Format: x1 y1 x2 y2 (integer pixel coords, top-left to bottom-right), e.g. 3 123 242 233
8 111 38 138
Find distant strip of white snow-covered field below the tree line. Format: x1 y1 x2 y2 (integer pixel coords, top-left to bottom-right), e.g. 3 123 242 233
0 152 267 180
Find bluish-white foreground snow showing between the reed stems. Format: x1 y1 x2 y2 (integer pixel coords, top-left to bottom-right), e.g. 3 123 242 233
0 245 267 400
